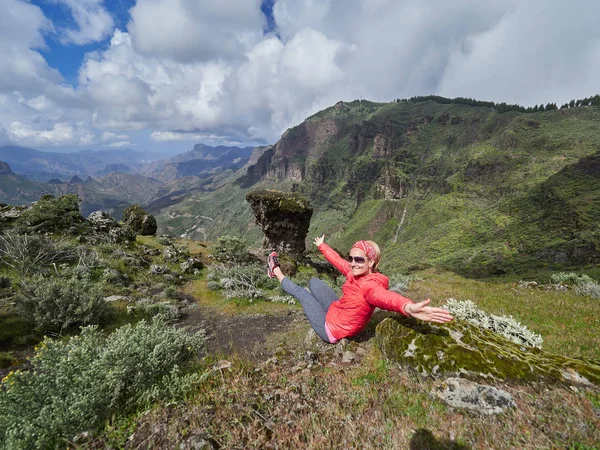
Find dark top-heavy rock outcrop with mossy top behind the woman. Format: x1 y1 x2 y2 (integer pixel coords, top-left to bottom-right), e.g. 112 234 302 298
246 190 313 257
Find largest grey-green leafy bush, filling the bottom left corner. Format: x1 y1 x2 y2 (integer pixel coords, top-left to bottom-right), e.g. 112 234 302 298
0 321 204 449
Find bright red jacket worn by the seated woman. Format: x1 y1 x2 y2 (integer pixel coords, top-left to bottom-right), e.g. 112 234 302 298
319 243 412 339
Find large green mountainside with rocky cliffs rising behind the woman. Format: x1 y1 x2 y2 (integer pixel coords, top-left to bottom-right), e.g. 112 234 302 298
159 100 600 277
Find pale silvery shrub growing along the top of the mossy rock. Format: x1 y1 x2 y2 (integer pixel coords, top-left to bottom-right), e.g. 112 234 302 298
443 298 543 348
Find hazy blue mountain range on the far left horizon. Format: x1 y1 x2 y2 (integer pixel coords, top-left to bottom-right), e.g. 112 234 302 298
0 146 162 182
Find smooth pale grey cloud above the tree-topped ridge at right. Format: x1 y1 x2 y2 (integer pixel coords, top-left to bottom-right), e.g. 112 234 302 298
439 0 600 106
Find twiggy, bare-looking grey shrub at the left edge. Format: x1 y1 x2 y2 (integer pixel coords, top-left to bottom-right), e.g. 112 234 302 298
0 231 76 275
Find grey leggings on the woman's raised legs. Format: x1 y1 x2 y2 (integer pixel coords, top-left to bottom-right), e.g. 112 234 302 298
281 277 338 343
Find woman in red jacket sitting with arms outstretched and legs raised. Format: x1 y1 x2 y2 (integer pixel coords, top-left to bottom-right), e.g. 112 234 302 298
267 235 452 344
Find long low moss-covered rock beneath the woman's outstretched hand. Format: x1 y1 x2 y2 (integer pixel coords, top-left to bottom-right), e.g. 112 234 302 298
376 317 600 386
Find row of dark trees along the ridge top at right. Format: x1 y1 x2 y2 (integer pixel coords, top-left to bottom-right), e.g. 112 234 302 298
394 94 600 113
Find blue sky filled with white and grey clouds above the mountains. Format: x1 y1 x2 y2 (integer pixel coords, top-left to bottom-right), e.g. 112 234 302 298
0 0 600 153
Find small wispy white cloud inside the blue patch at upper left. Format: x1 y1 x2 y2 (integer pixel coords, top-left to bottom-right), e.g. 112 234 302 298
50 0 114 45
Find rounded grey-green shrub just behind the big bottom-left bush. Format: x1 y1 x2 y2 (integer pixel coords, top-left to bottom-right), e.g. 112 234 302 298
15 277 110 333
